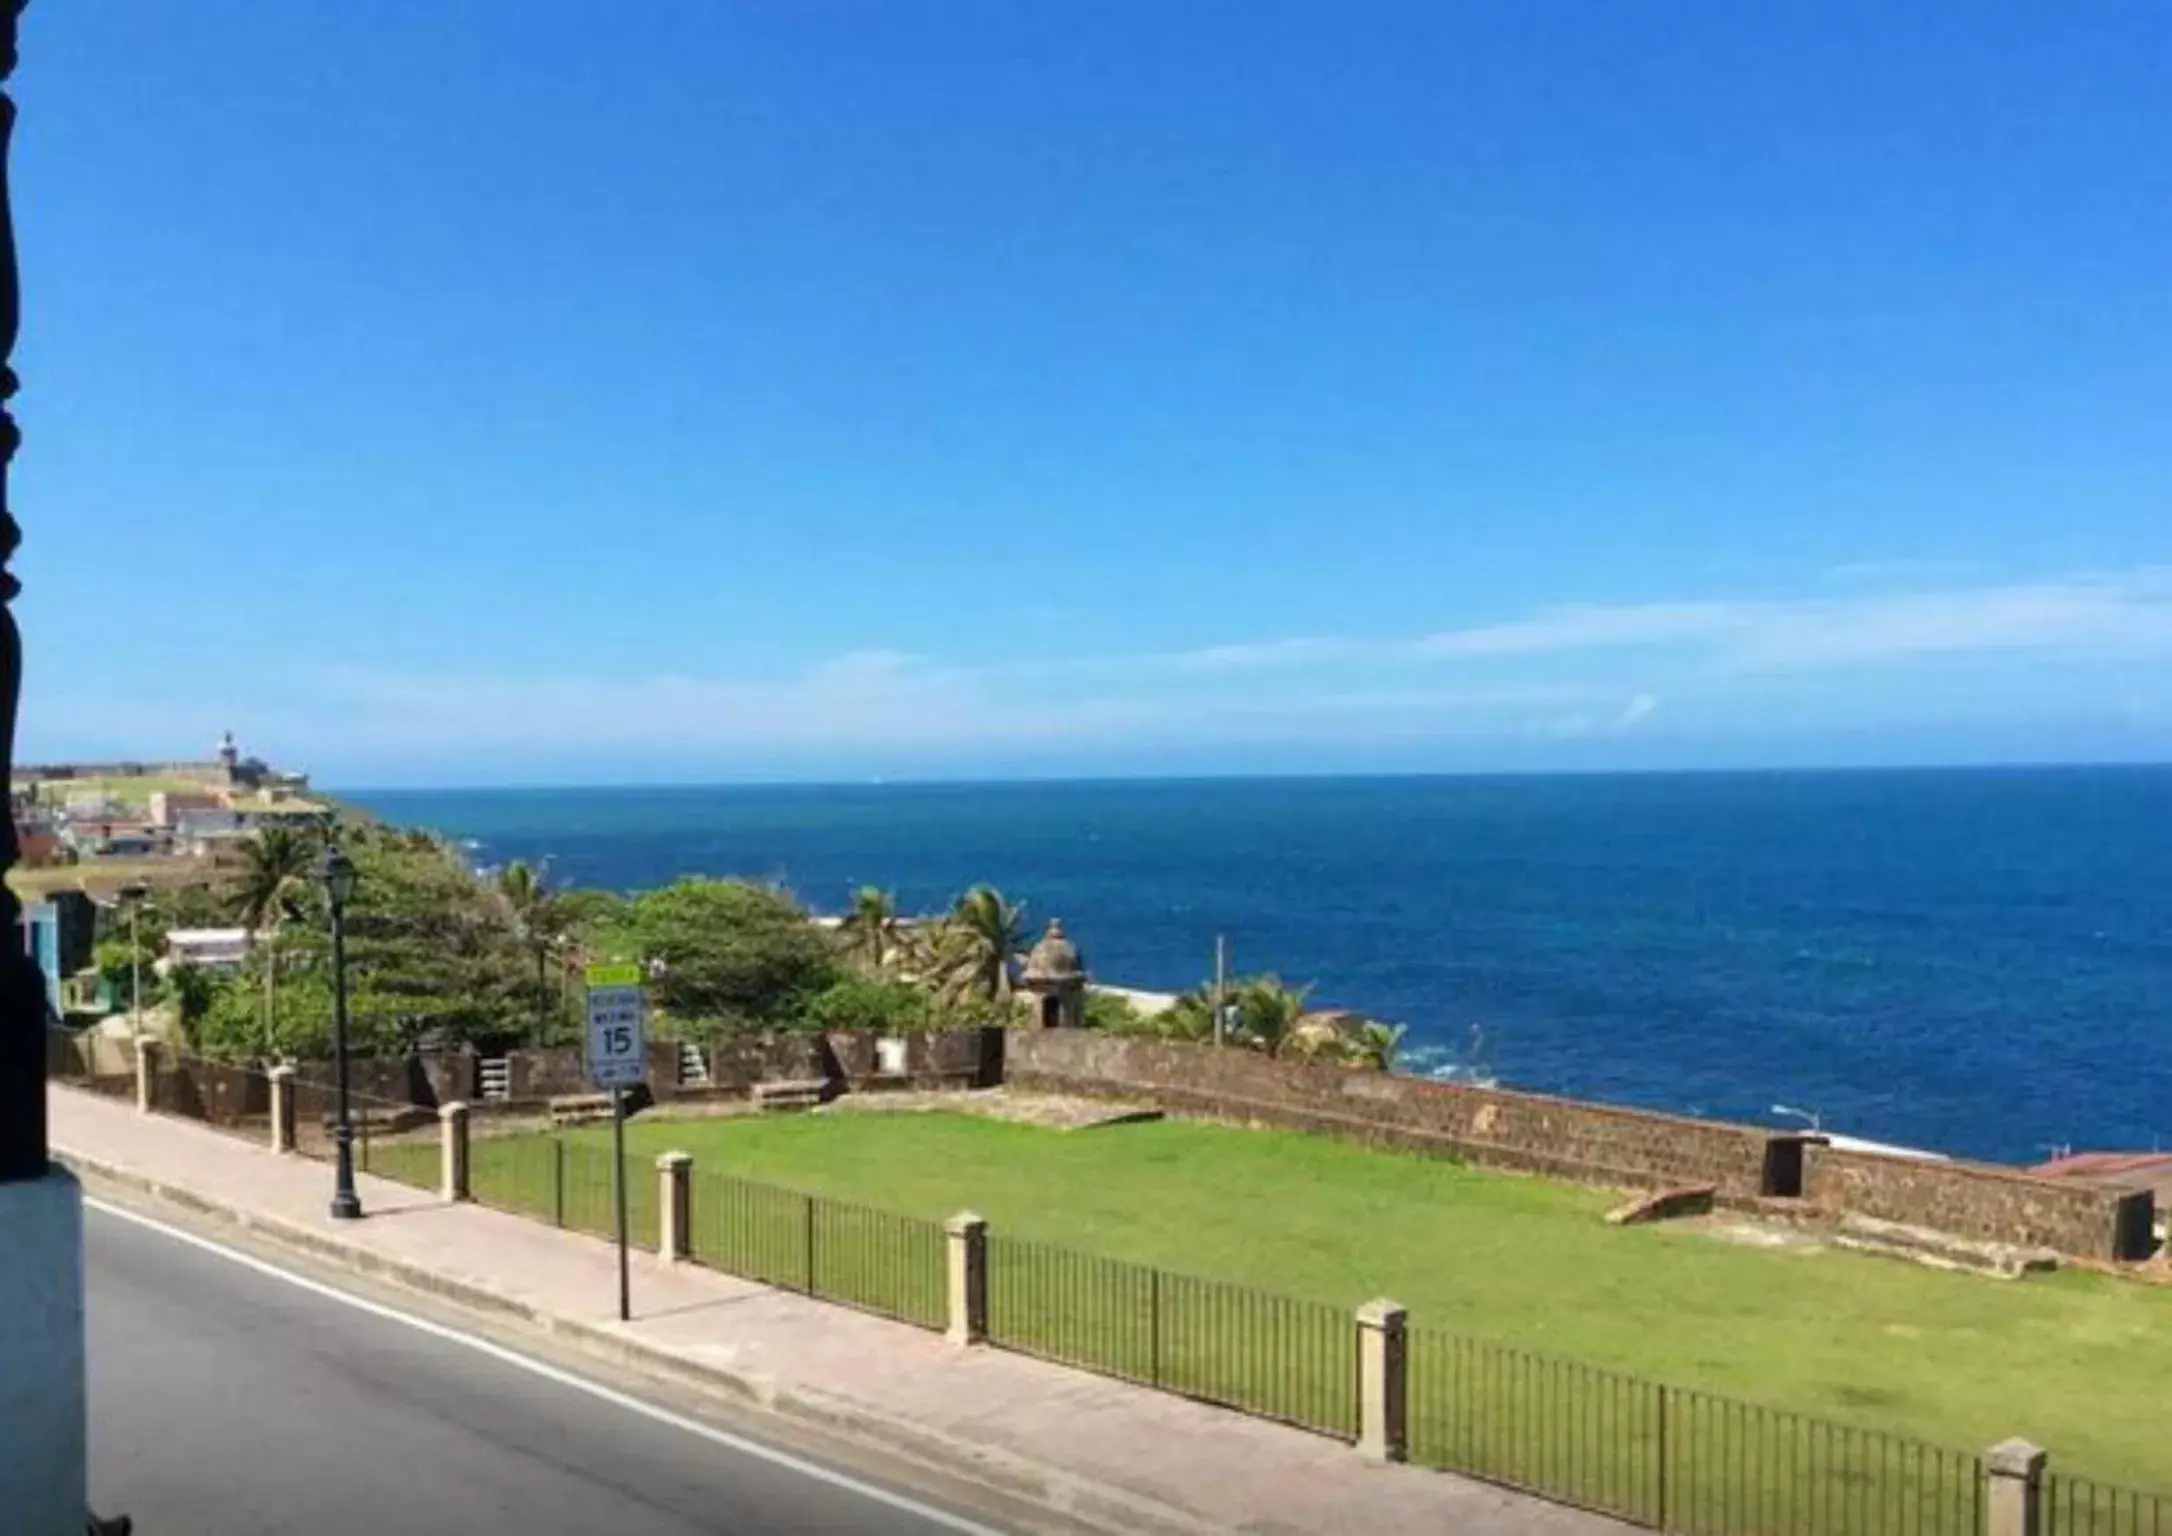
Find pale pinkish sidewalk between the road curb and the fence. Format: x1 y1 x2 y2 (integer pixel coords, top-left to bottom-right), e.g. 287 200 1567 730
52 1086 1625 1536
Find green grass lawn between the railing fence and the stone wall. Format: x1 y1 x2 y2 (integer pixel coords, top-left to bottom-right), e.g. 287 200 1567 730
462 1112 2172 1488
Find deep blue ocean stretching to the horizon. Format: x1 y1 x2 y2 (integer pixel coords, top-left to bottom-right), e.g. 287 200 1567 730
350 767 2172 1162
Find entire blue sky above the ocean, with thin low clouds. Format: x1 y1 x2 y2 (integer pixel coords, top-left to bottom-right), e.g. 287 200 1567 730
15 0 2172 784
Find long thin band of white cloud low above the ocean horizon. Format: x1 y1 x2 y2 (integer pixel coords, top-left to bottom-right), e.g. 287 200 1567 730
42 569 2172 760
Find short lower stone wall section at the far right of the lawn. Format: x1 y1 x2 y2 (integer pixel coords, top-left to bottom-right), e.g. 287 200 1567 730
1805 1145 2157 1260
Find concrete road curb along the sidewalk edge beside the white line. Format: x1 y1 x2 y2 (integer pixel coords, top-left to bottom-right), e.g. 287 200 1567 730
52 1147 1227 1536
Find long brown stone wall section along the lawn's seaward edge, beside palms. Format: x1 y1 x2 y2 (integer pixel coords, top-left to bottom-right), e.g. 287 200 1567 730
1006 1030 1775 1199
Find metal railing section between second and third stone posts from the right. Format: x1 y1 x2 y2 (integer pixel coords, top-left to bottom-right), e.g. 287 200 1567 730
988 1234 1358 1440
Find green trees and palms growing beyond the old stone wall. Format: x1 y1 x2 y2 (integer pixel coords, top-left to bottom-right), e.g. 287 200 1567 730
160 821 1401 1067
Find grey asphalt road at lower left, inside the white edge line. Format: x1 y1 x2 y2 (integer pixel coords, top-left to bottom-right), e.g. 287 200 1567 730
89 1210 1020 1536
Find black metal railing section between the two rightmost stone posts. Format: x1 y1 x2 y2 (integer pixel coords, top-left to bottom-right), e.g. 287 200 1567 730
1407 1327 1983 1536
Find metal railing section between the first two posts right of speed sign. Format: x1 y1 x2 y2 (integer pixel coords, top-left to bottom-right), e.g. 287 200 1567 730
686 1173 949 1327
